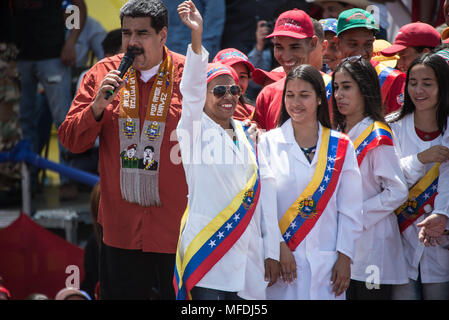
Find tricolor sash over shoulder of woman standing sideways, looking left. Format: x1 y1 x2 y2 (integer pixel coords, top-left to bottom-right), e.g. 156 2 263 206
354 121 393 166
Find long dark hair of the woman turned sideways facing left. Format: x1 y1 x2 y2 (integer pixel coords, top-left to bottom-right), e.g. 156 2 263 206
332 57 385 131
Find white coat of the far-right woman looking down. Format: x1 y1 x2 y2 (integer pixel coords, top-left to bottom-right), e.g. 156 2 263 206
390 113 449 283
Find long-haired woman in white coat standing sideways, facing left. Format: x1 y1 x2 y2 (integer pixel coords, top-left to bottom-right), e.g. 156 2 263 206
332 56 408 300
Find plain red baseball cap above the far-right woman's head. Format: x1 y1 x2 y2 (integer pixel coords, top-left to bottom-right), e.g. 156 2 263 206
381 22 441 56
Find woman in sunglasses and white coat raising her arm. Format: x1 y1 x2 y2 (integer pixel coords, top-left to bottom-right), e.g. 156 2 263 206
174 1 279 300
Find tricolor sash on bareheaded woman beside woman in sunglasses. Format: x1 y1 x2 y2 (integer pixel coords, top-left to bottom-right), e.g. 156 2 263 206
279 127 349 251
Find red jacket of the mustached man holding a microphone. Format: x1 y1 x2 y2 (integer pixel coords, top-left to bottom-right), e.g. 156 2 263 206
58 51 187 253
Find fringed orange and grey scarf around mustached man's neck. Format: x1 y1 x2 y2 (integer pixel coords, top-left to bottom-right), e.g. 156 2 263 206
118 47 174 207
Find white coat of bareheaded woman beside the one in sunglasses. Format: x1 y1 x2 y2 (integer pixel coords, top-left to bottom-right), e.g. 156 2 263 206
259 120 363 300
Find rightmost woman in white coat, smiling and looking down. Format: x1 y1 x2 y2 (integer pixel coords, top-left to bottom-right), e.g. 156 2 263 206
388 54 449 300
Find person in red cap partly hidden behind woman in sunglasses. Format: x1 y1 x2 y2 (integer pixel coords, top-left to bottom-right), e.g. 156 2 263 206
212 48 255 121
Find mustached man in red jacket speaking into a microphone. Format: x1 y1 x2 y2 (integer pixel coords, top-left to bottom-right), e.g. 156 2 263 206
58 0 187 299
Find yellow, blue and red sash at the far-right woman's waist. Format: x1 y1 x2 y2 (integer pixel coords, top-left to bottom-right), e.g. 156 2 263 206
395 163 440 233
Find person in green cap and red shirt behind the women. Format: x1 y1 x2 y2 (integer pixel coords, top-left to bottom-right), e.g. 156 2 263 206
334 9 405 114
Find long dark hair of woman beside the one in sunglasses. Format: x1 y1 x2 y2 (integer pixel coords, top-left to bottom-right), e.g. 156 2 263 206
278 64 331 128
